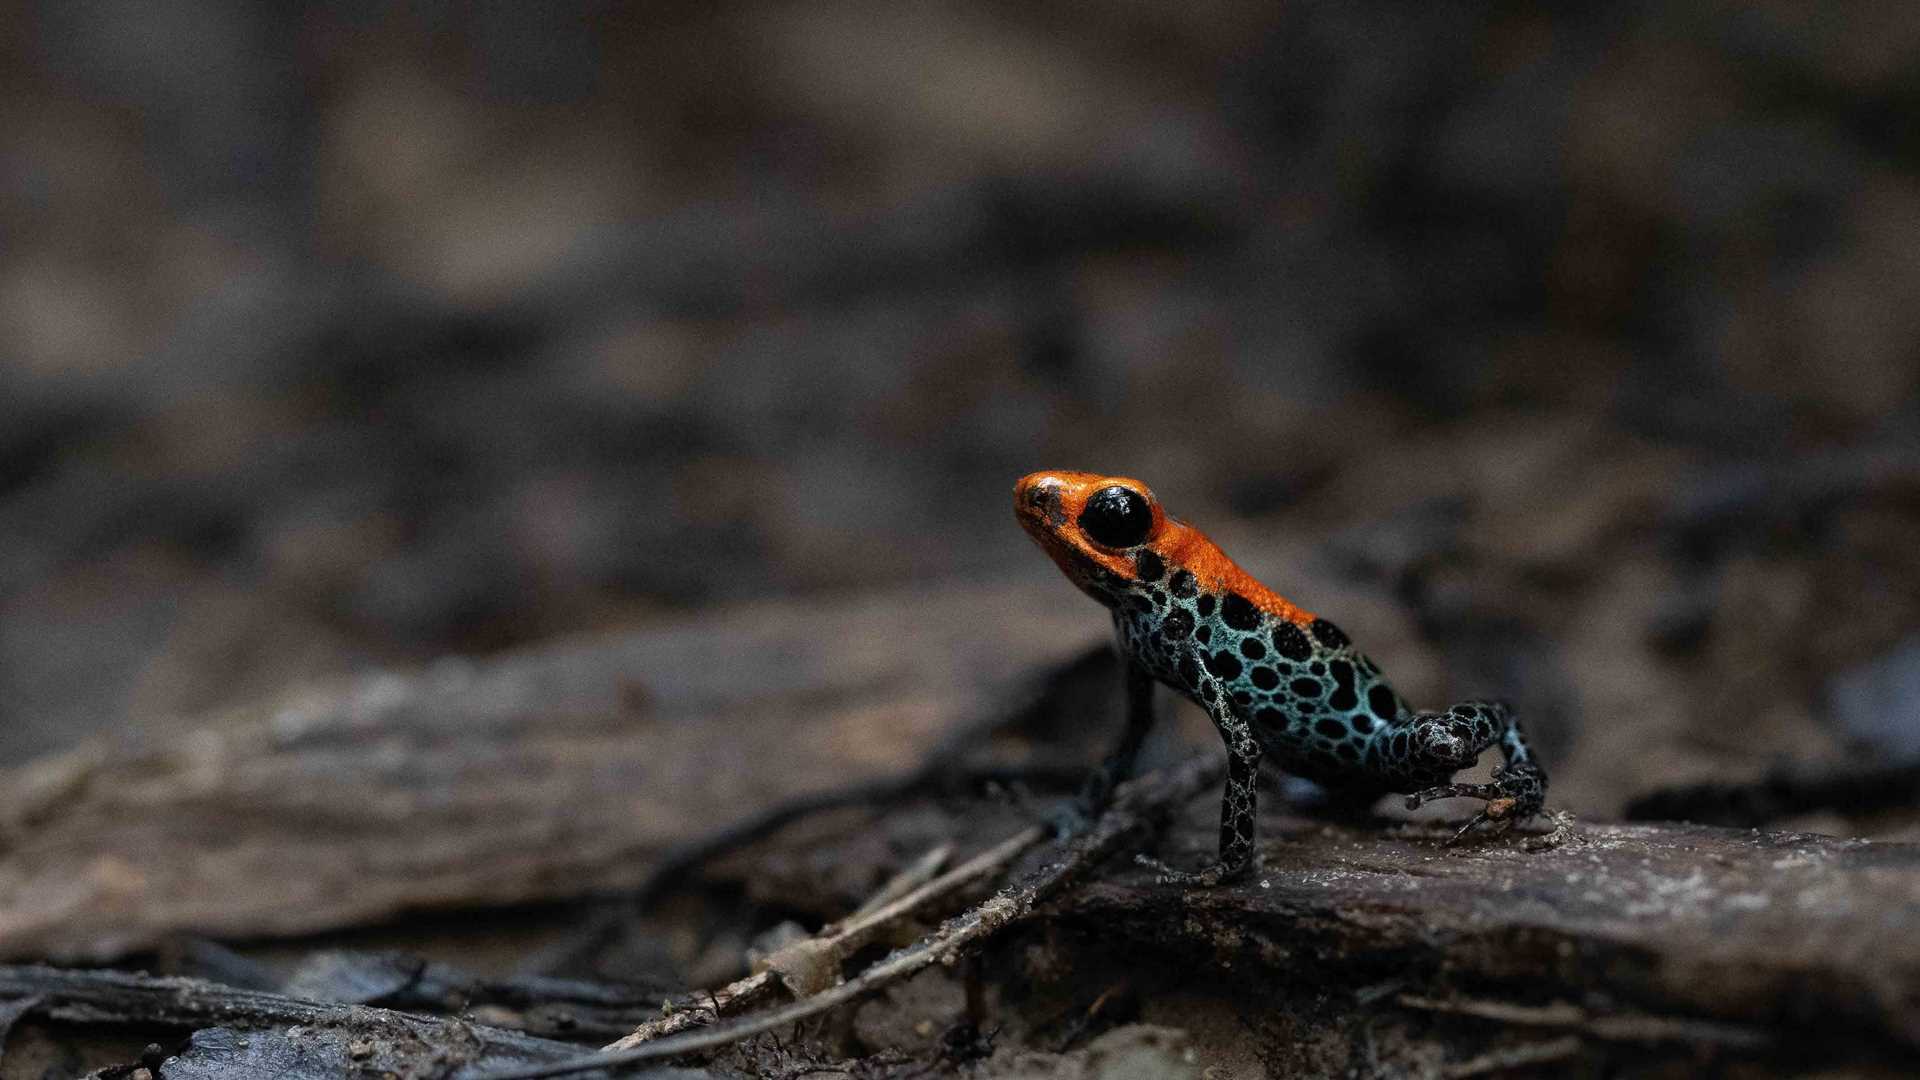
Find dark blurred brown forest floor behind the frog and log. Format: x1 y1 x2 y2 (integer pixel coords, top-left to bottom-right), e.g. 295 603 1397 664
0 0 1920 818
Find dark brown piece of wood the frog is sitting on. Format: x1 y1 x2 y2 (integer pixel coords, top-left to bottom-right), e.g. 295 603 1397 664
1054 813 1920 1057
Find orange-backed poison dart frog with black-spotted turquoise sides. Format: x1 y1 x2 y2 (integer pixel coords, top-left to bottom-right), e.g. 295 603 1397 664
1014 471 1548 886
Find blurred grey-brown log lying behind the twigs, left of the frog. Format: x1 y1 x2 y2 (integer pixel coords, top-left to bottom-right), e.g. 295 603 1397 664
0 586 1102 961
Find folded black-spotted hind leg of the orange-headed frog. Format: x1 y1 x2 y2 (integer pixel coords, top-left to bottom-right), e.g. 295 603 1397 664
1373 701 1548 840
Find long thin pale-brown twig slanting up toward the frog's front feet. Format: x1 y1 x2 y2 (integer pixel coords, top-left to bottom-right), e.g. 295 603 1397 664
468 757 1223 1080
